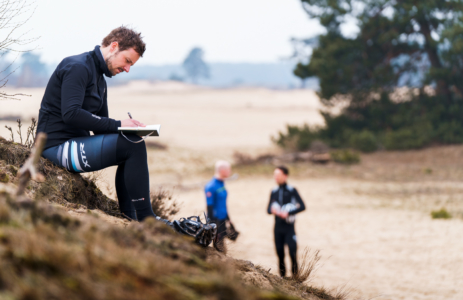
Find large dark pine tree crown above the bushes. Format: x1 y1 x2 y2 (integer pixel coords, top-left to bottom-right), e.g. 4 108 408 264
295 0 463 103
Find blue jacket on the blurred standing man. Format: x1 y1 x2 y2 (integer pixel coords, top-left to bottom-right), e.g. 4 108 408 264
204 177 228 221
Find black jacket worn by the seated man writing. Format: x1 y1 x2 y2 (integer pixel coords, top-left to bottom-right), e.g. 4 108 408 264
37 46 121 149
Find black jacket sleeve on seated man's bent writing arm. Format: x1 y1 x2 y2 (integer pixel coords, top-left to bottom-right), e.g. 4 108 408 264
61 64 121 132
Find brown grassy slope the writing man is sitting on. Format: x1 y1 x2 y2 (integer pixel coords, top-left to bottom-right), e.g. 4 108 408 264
0 140 342 299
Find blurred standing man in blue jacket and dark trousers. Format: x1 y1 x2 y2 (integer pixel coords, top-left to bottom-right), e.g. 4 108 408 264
204 160 237 252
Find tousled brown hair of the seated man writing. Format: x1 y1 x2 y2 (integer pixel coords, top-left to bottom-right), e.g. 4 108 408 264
101 25 146 57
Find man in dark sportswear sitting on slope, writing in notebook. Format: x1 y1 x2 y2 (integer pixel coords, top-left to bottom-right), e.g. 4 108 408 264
37 26 215 243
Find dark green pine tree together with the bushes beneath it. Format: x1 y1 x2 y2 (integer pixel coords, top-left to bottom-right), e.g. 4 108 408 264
282 0 463 152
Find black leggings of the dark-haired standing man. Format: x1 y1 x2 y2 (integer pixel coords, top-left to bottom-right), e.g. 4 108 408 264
274 226 298 277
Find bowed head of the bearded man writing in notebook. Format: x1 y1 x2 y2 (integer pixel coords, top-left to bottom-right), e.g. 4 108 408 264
101 26 146 76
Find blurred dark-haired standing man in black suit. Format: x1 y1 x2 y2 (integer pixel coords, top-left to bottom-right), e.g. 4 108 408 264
267 166 305 277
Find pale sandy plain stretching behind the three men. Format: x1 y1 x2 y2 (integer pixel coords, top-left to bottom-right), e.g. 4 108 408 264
0 82 463 300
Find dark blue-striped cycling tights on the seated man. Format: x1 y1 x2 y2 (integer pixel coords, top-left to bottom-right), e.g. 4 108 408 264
42 133 155 221
